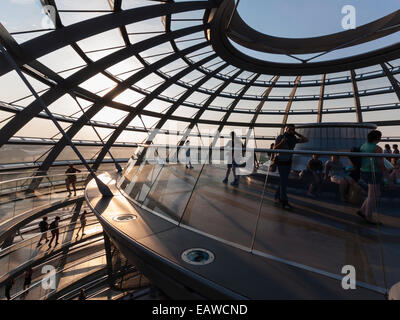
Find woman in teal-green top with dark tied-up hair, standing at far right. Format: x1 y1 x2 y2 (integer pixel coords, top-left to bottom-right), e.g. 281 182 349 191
357 130 389 224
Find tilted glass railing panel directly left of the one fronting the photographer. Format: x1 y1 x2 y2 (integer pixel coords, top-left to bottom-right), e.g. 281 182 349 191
182 163 263 250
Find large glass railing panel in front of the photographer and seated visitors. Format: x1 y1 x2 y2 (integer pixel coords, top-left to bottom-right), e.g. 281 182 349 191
253 150 400 293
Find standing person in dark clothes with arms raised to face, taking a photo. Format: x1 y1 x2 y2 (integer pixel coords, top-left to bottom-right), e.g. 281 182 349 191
275 124 308 208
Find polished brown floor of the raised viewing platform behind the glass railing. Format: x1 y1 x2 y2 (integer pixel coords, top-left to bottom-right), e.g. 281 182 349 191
86 165 400 300
